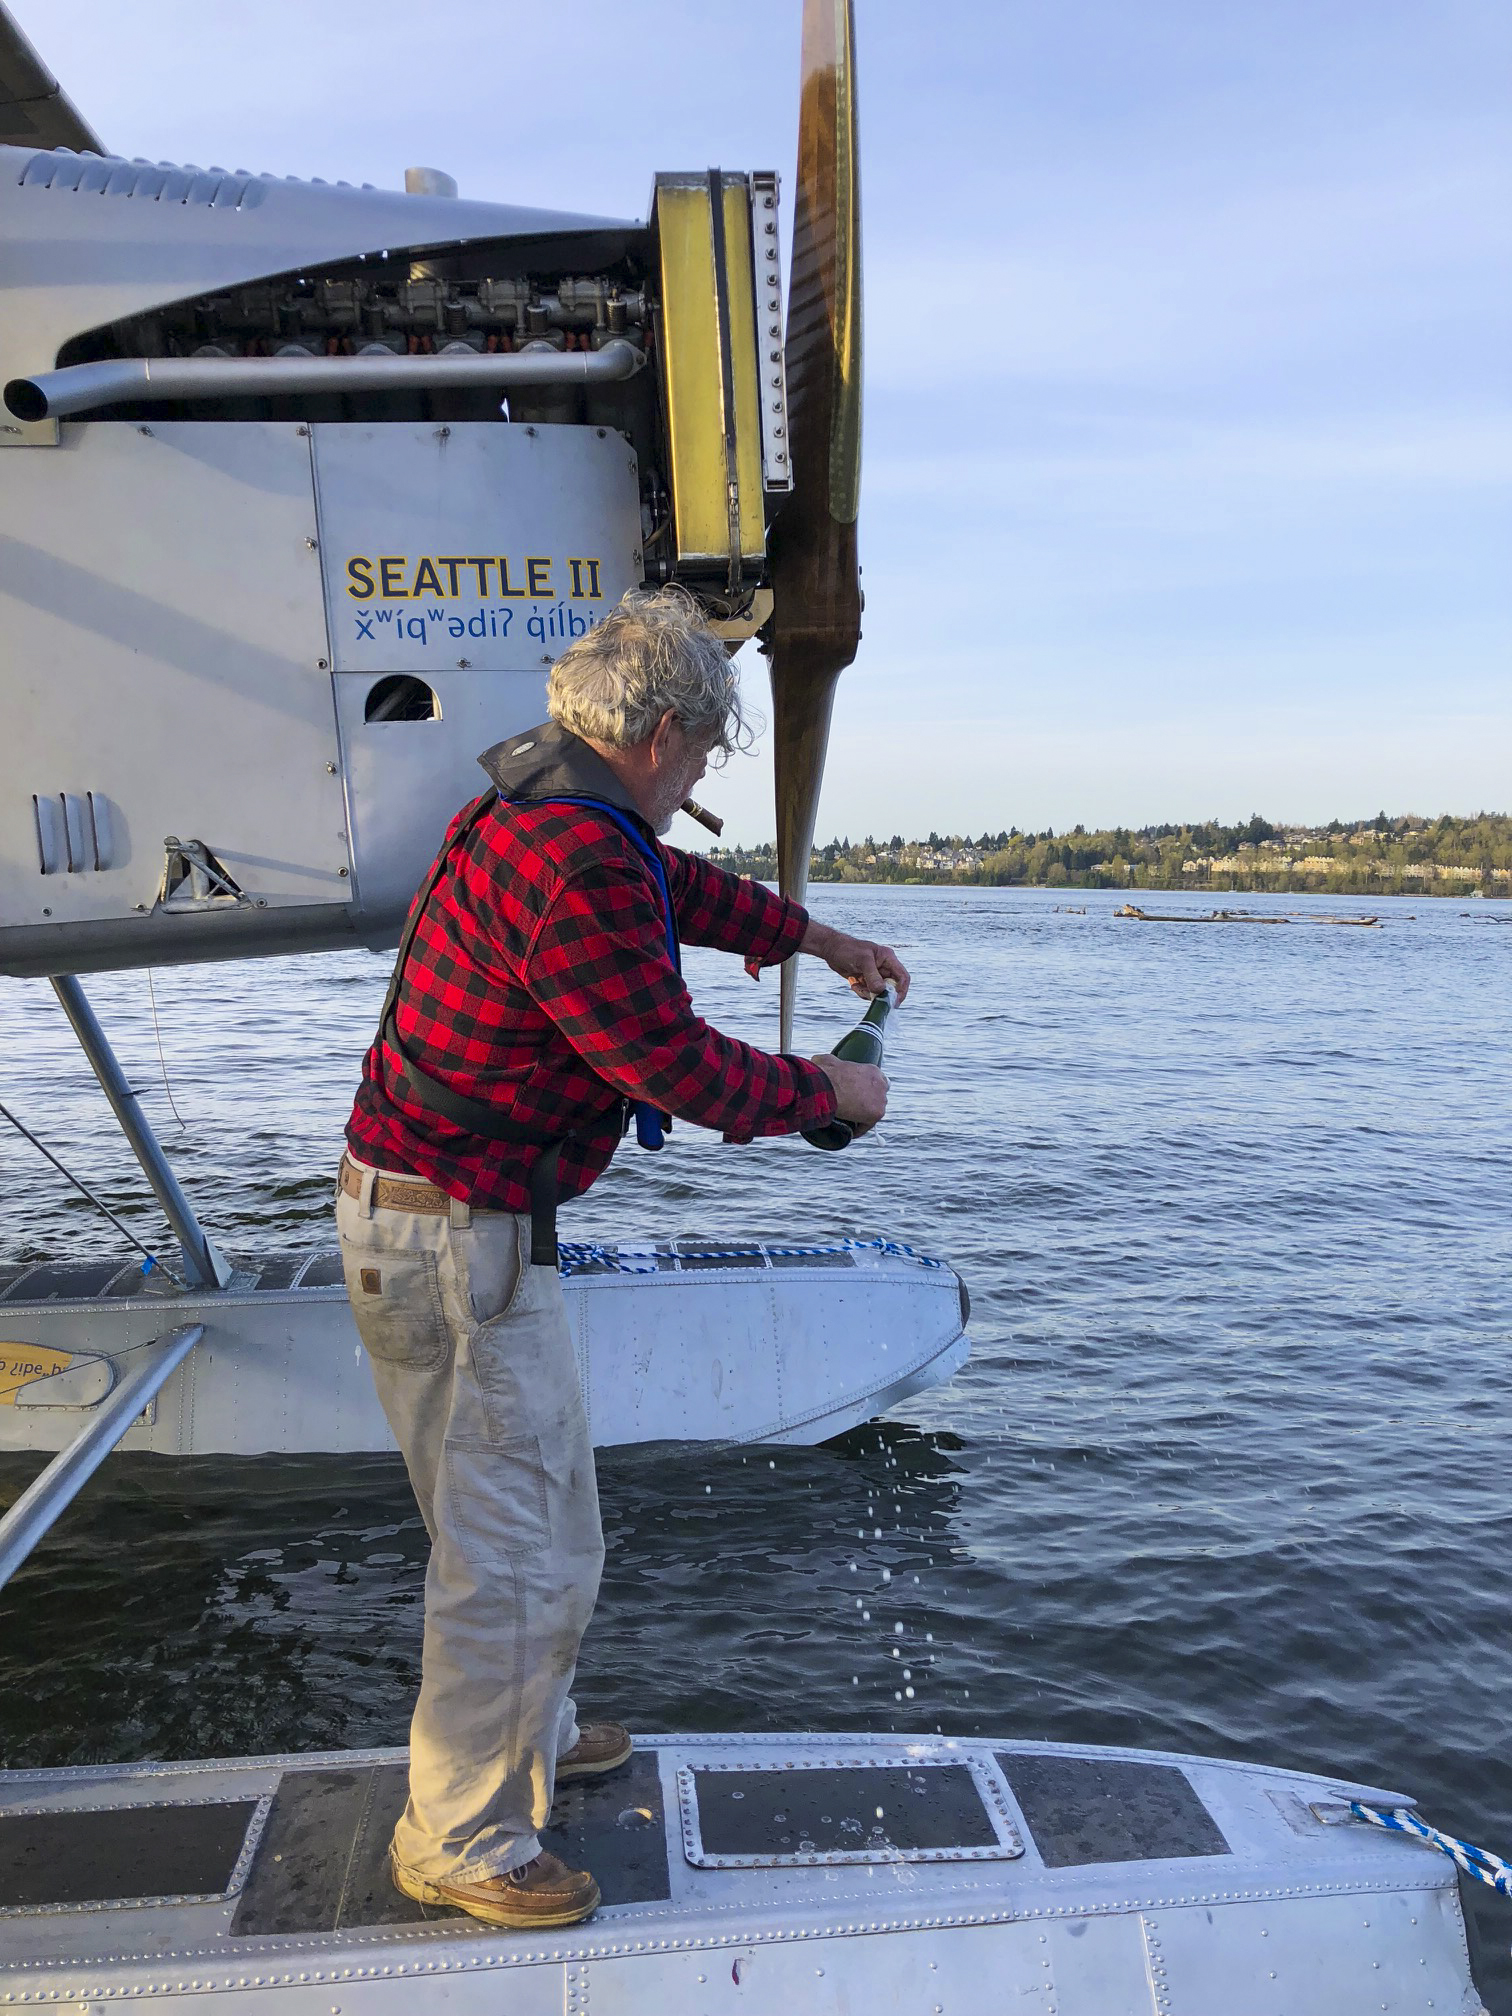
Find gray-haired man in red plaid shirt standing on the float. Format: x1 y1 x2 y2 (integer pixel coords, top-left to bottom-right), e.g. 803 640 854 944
337 589 909 1927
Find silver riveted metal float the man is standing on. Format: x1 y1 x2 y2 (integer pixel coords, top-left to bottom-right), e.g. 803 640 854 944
0 1736 1480 2016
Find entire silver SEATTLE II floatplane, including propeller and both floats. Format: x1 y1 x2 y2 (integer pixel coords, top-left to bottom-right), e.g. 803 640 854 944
0 0 1480 2016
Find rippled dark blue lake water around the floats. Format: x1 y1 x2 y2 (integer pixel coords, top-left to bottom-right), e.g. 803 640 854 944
0 887 1512 2010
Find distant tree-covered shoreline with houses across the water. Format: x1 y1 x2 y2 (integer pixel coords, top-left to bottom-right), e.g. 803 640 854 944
712 812 1512 897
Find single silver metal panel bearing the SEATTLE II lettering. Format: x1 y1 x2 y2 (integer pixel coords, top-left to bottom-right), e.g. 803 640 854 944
320 421 641 919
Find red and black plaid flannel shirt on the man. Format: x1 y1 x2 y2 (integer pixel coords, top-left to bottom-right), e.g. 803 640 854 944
347 800 835 1212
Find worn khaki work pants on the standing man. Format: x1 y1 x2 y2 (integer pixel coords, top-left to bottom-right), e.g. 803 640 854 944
337 1155 603 1881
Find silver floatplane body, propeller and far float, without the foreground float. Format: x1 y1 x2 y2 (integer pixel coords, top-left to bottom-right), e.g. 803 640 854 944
0 0 968 1491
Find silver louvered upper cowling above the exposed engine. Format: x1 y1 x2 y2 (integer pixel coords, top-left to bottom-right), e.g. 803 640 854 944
0 147 629 377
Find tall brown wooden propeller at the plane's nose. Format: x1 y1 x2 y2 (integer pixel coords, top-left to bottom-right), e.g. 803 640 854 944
766 0 861 1048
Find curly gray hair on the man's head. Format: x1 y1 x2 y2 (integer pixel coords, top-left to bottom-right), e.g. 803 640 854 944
546 587 756 756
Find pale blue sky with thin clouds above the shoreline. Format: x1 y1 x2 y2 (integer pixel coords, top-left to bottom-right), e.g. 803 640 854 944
23 0 1512 839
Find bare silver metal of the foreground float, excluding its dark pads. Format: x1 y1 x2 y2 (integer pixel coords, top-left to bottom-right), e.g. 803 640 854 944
0 1736 1480 2016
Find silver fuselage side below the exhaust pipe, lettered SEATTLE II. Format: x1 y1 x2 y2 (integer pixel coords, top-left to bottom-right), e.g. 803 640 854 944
0 421 661 972
